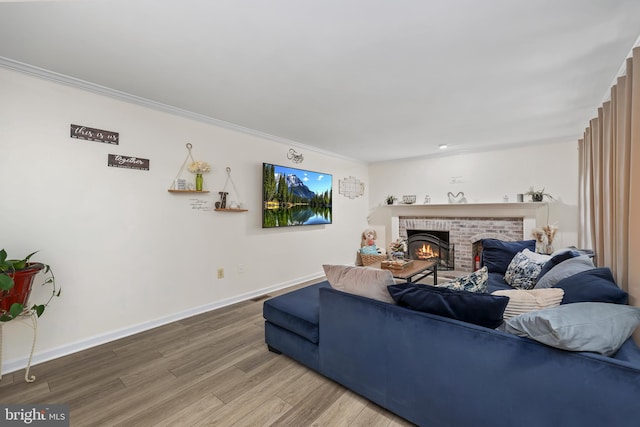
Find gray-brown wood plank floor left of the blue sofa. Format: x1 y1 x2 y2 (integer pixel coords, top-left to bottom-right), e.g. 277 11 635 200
0 280 413 427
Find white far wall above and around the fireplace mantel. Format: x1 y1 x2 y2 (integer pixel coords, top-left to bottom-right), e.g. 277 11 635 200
369 141 578 248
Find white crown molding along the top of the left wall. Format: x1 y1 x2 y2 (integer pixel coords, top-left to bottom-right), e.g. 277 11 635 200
0 56 366 163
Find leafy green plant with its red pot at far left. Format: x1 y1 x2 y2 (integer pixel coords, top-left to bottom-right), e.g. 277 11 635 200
0 249 60 322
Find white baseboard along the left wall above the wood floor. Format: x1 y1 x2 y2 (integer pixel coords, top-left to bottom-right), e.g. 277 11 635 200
0 273 324 373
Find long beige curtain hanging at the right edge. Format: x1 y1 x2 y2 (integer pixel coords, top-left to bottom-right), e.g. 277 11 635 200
578 47 640 306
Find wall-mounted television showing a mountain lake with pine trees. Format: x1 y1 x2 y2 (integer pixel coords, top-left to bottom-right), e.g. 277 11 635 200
262 163 333 228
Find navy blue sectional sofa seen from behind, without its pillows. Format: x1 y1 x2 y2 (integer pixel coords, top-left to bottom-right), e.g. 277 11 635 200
263 268 640 427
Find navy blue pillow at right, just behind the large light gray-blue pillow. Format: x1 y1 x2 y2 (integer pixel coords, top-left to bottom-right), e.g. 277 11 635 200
553 267 629 304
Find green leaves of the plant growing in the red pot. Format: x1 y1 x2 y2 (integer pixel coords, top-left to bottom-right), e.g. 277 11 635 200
0 249 60 322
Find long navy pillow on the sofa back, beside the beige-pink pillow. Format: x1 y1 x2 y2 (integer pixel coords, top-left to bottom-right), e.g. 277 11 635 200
387 283 509 329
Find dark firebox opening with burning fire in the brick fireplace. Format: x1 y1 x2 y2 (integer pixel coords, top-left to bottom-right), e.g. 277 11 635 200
407 230 455 270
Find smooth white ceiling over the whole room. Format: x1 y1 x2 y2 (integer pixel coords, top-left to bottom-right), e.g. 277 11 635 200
0 0 640 162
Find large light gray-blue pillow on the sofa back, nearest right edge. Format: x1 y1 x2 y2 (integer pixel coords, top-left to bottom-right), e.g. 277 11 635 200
504 302 640 356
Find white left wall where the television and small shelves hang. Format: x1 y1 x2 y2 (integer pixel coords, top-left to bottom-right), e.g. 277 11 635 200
0 69 369 372
